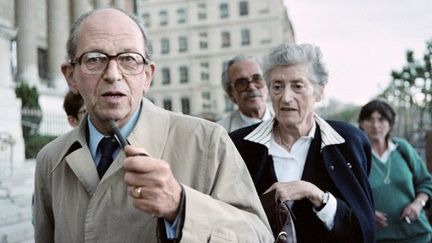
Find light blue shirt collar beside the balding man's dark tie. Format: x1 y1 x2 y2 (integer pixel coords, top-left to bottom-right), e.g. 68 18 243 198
87 101 142 159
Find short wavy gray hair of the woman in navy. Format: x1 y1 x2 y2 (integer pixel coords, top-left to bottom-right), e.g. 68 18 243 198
262 43 328 85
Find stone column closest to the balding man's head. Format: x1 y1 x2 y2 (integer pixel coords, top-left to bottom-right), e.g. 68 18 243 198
47 0 69 91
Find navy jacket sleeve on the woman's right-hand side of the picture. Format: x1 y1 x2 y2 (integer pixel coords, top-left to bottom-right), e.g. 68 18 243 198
323 127 375 243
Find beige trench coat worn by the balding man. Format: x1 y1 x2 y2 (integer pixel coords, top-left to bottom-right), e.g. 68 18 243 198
34 99 273 243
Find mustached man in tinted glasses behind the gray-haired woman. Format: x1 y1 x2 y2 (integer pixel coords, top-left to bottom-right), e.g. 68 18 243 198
217 55 274 132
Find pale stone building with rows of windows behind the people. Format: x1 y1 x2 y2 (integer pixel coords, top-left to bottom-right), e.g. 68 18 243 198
140 0 294 120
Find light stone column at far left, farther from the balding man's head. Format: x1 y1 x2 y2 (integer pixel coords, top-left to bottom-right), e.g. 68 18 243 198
15 0 39 86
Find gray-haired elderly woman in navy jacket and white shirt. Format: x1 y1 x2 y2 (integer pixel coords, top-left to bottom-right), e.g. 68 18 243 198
230 44 375 243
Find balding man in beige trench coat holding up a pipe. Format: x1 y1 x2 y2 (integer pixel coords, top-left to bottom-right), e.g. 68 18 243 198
35 9 273 243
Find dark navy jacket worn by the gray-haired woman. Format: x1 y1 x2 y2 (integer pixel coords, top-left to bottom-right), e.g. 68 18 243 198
230 121 375 243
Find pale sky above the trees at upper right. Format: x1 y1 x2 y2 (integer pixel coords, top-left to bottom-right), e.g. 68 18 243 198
285 0 432 105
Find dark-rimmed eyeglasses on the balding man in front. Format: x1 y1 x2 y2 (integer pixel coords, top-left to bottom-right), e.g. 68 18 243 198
69 51 148 75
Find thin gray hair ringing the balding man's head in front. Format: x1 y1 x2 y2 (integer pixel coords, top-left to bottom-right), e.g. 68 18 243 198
66 7 153 61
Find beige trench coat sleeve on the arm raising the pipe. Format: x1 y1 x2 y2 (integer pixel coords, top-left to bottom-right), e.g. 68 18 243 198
181 127 273 242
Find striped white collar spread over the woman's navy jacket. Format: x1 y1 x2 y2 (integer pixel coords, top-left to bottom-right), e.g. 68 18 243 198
244 114 345 149
